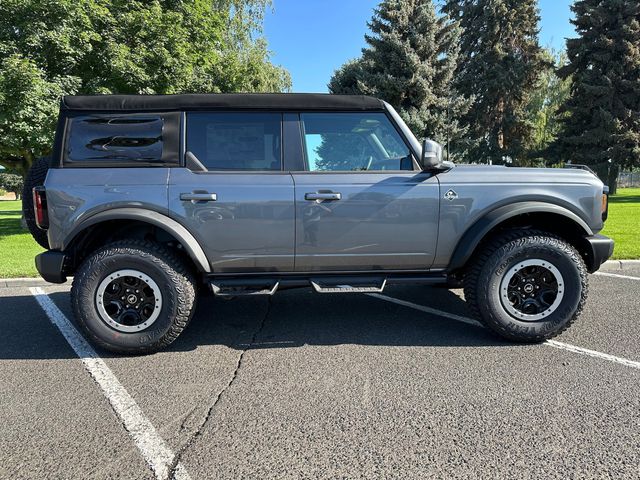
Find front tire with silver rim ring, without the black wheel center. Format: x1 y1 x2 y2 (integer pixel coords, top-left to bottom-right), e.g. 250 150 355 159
464 230 589 342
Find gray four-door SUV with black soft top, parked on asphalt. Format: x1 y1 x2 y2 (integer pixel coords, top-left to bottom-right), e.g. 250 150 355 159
24 94 613 353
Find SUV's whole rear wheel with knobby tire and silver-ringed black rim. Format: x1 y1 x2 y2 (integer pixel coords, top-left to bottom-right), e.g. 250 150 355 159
71 240 197 354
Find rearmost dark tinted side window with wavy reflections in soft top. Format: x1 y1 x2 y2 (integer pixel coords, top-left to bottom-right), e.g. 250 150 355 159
65 115 164 164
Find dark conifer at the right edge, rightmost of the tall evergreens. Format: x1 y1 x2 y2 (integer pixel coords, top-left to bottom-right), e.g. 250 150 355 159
558 0 640 188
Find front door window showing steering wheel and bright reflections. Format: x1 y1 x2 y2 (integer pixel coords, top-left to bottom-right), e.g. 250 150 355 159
301 113 413 172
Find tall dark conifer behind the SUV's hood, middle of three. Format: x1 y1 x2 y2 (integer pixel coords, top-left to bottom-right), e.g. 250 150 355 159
443 0 550 164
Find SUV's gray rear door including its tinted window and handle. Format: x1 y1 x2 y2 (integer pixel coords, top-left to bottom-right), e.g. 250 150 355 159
169 112 295 273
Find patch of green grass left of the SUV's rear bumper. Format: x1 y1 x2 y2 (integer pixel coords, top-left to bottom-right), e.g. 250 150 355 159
0 200 44 278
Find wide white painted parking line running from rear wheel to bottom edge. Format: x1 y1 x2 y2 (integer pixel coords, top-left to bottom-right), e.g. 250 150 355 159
29 287 191 480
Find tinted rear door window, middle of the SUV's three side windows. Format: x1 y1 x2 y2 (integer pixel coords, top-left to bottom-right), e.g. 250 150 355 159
187 113 282 170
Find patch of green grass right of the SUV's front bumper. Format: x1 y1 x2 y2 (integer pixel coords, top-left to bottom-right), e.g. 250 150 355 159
602 188 640 260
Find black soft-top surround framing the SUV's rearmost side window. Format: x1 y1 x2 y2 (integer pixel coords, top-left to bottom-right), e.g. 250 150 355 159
59 111 180 168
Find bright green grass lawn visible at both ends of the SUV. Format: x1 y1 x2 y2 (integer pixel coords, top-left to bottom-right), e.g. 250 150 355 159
0 188 640 278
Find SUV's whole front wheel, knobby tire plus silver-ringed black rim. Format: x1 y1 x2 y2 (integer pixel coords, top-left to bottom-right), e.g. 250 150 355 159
464 230 589 343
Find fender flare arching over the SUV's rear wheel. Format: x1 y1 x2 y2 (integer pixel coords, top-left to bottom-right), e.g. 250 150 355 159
62 207 211 273
